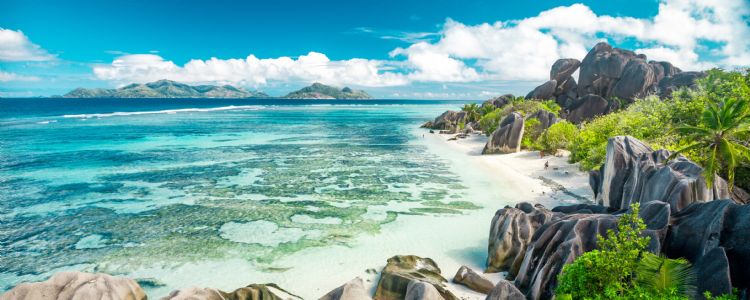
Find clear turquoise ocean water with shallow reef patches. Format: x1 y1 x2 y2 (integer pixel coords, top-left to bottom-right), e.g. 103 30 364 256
0 99 480 290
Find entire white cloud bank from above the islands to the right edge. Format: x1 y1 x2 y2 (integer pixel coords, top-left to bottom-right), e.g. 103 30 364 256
94 0 750 87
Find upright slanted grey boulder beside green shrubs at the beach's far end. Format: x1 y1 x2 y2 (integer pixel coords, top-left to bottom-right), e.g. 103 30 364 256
482 112 524 154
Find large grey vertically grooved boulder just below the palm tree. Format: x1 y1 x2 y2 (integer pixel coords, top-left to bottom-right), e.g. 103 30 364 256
590 136 731 212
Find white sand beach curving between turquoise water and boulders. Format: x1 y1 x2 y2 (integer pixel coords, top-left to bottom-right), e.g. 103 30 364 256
128 129 593 299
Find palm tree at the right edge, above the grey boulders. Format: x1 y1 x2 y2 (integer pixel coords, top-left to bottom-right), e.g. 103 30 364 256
670 99 750 190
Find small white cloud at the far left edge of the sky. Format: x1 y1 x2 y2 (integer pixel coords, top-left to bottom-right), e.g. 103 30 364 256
0 28 55 62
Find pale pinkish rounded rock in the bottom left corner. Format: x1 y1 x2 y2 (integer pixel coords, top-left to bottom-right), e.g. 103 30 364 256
0 272 146 300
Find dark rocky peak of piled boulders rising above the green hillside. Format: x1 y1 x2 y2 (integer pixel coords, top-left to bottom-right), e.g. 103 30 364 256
526 42 705 123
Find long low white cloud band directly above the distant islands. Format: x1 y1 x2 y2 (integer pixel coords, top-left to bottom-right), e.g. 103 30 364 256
94 52 406 87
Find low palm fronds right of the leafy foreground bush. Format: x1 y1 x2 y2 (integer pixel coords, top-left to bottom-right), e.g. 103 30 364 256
635 252 696 298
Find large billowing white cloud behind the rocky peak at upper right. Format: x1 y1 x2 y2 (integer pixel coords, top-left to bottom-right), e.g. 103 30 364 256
391 0 750 81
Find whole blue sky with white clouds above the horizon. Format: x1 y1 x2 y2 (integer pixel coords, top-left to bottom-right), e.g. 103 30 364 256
0 0 750 99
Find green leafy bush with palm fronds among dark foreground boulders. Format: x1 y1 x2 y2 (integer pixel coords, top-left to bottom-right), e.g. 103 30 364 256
555 204 694 300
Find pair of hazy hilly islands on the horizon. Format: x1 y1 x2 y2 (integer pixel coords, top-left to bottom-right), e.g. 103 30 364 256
62 79 372 99
